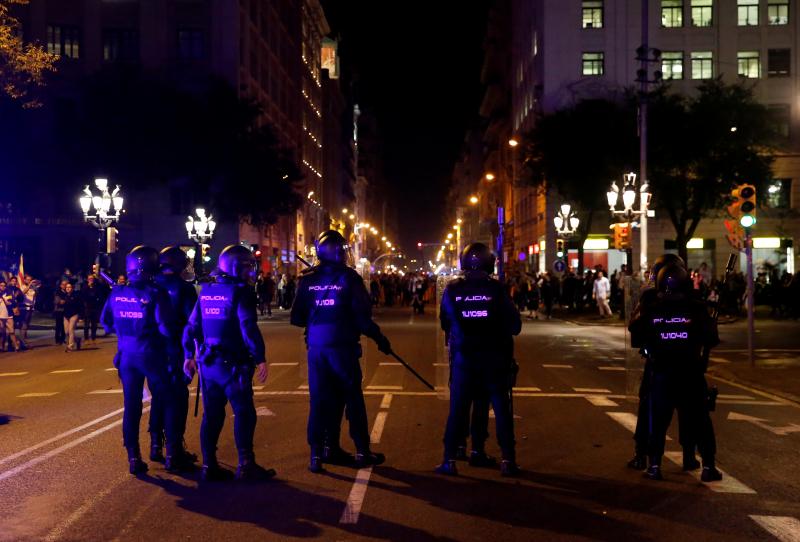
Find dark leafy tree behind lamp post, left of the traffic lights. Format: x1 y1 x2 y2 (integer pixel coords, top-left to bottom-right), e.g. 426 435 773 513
523 99 637 273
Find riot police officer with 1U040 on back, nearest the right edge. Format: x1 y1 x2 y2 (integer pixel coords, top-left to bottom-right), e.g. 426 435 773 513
629 263 722 482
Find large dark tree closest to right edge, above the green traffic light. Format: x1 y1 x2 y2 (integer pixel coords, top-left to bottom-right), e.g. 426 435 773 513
648 79 776 260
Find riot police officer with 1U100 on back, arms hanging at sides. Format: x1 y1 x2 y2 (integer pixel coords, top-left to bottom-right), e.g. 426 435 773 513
183 245 275 481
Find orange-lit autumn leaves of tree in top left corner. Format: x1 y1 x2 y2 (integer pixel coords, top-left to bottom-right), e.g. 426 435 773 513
0 0 58 107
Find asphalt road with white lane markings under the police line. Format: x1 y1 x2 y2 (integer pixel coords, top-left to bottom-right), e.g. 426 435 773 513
0 309 800 541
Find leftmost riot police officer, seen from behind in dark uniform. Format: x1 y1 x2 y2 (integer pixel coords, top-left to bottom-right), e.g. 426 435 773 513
101 246 187 474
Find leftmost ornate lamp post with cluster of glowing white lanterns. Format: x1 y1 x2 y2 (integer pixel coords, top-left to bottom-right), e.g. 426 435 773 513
78 179 123 273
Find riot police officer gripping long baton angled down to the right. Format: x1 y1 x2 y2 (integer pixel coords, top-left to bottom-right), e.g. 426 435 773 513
291 230 392 473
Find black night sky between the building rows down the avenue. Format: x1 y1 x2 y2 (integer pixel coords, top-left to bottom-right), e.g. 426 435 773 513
322 0 489 250
